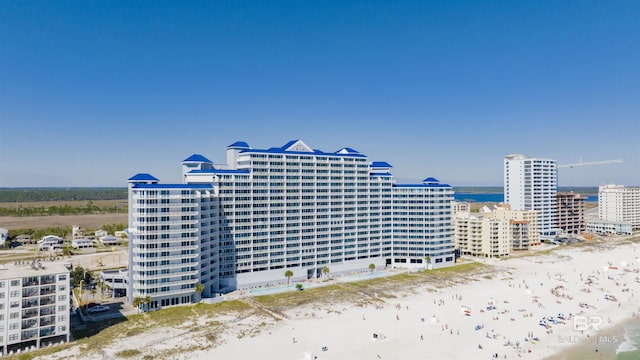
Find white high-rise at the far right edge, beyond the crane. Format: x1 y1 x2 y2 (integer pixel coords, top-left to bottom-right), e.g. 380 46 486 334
598 184 640 230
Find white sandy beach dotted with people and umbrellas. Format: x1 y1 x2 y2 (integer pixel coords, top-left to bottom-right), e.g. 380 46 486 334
41 236 640 360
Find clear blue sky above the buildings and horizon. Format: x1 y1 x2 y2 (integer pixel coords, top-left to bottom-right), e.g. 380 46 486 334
0 0 640 187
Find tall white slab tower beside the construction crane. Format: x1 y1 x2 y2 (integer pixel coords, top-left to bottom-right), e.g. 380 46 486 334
504 154 558 238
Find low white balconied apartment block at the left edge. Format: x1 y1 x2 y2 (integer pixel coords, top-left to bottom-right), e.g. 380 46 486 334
0 261 71 355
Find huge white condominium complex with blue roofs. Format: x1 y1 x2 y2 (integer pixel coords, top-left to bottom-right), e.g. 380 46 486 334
128 140 454 308
